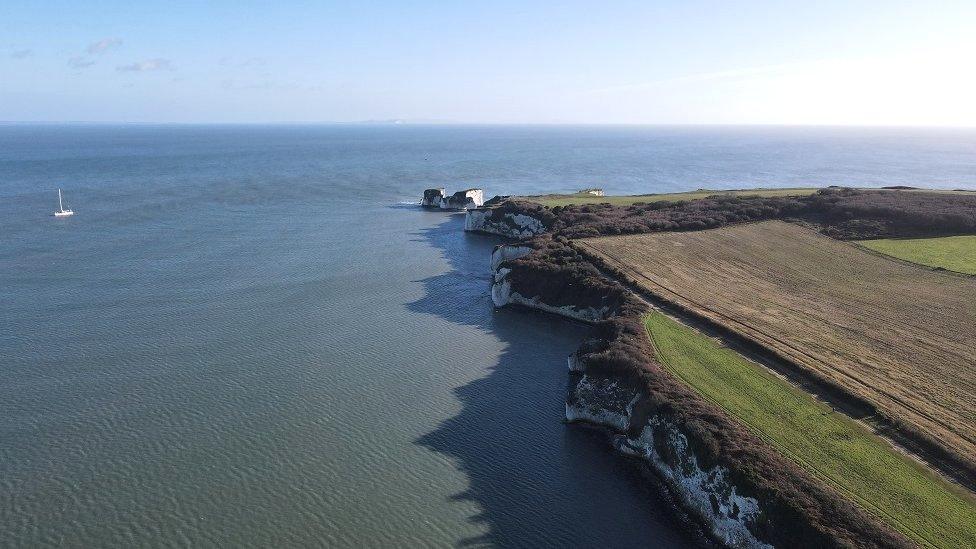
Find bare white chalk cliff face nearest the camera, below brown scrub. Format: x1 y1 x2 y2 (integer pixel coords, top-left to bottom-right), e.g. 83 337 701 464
566 353 771 548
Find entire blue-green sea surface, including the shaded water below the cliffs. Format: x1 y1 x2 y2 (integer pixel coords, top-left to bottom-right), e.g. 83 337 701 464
0 125 976 547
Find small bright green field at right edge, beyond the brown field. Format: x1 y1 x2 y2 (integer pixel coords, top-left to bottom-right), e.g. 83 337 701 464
859 235 976 274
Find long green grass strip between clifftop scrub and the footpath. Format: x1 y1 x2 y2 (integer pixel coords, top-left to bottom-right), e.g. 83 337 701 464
644 312 976 548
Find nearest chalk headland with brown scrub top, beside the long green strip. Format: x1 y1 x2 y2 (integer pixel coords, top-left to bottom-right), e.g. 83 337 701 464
566 306 912 548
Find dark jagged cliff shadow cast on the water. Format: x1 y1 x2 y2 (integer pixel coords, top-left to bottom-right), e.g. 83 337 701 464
408 215 704 547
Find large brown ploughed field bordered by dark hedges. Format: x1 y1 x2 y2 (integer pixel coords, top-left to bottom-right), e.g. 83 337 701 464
577 221 976 470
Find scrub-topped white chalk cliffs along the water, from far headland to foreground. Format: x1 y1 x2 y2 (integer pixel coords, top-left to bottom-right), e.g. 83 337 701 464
456 187 976 547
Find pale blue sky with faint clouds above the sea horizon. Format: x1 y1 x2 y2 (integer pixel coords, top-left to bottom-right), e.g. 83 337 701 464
0 0 976 127
